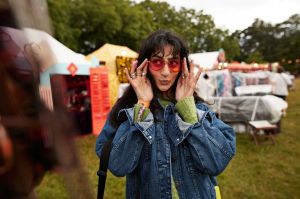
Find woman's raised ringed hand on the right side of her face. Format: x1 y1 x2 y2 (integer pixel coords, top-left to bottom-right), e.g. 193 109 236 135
176 58 201 101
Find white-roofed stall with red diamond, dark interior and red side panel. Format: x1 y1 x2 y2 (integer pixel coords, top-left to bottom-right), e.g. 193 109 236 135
3 28 109 134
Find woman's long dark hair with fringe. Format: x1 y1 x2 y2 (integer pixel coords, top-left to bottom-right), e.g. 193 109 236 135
109 30 203 127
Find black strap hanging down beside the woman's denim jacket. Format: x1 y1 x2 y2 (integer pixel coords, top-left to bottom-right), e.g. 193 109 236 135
97 138 113 199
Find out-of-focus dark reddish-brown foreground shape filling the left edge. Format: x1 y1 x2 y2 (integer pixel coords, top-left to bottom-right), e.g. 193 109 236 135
0 0 92 198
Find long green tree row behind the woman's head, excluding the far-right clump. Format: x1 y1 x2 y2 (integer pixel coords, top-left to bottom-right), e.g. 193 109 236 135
48 0 239 59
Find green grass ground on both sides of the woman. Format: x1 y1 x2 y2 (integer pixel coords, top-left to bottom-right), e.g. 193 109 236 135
37 79 300 199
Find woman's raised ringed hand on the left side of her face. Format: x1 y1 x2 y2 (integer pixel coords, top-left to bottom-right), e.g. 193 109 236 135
125 59 153 102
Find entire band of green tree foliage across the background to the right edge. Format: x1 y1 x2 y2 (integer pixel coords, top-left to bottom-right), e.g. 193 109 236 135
48 0 300 72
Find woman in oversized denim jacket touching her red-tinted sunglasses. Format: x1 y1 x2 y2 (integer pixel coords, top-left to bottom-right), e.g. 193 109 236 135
96 30 235 199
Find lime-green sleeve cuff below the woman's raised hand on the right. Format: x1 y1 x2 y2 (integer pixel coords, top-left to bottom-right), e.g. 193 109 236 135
175 96 198 124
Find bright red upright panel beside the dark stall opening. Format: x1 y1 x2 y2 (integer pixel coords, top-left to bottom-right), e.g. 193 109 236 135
90 66 110 135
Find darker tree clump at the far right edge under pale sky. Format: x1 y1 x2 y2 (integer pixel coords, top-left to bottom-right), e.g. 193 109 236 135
236 14 300 69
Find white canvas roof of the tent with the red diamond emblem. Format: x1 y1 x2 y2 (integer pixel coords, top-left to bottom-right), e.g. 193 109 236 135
1 27 91 110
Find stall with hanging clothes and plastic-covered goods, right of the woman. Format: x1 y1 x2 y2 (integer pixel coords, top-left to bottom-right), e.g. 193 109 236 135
196 69 287 131
